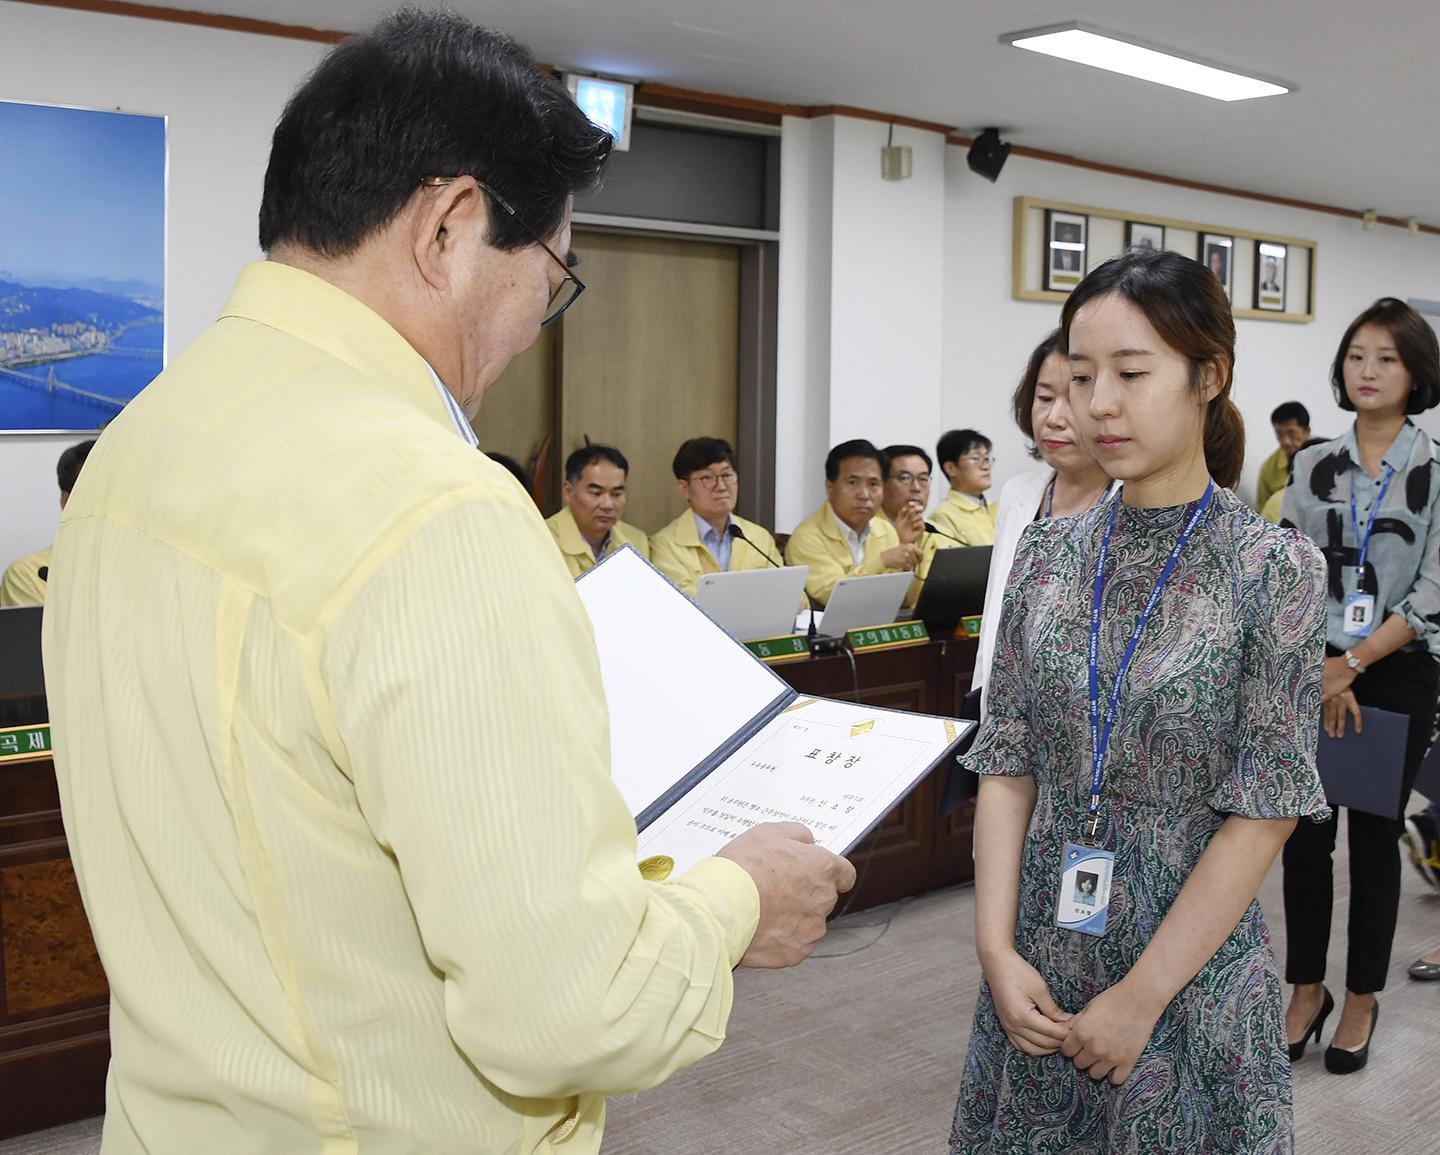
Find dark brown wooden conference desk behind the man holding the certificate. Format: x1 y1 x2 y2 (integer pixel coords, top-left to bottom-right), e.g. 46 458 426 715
0 641 975 1138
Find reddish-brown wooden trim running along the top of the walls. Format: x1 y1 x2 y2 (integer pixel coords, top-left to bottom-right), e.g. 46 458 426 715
12 0 1440 235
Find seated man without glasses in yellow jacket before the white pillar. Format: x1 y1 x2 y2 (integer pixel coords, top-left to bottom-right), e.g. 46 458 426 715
785 439 920 606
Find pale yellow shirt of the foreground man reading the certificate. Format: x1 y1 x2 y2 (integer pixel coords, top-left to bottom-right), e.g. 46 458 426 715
45 262 759 1155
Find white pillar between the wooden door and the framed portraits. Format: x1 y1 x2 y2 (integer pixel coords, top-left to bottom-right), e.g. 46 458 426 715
775 117 946 531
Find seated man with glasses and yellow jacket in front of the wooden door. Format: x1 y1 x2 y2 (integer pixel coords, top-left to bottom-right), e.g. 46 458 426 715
649 438 780 598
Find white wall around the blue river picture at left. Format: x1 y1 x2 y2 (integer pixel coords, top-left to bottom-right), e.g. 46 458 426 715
0 3 325 567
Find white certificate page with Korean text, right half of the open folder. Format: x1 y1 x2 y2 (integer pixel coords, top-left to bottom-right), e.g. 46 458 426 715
639 698 975 873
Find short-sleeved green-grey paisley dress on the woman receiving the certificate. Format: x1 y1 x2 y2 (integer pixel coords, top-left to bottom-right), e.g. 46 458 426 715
950 490 1328 1155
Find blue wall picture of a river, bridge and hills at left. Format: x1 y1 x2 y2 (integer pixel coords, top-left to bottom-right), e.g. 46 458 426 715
0 101 166 433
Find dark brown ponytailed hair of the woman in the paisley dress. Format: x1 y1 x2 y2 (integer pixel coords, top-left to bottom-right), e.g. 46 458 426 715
1060 249 1246 490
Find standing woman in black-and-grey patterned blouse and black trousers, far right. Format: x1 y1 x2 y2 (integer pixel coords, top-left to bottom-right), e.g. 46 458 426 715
1280 297 1440 1074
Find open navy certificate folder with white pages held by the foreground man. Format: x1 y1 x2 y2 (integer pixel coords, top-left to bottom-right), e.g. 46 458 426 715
576 546 971 871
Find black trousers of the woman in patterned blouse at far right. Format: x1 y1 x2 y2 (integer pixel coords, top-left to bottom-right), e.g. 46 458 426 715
1283 650 1440 995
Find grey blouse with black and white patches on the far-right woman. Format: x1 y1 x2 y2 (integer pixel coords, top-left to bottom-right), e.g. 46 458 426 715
1280 421 1440 657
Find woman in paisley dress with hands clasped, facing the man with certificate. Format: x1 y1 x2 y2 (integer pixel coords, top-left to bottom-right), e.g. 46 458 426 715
950 252 1328 1155
